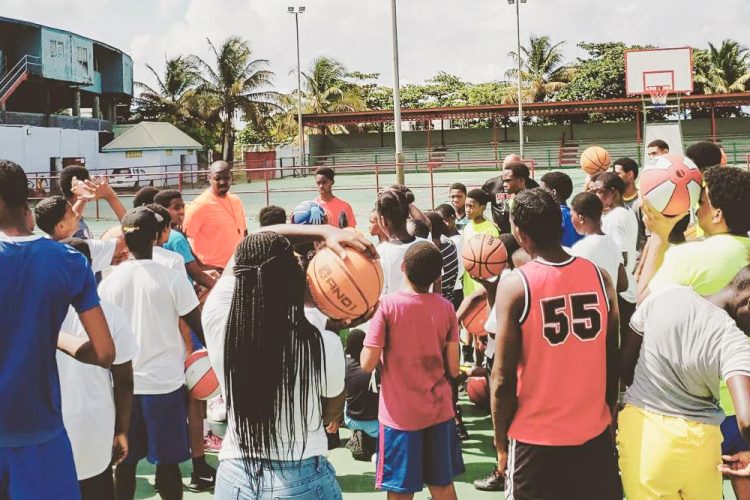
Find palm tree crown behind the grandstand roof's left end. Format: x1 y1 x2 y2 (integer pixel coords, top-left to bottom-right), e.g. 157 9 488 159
302 57 366 134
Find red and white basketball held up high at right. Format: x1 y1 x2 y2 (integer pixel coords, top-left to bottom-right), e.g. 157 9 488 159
640 153 703 216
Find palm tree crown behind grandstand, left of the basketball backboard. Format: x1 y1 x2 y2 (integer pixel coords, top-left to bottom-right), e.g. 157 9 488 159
506 35 568 102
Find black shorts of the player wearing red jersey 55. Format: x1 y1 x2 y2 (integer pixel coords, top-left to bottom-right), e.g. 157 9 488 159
505 428 622 500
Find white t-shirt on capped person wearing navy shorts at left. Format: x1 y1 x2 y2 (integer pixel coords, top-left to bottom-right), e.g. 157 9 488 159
99 259 198 394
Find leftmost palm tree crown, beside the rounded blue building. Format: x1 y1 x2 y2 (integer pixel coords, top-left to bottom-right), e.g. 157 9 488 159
135 56 200 124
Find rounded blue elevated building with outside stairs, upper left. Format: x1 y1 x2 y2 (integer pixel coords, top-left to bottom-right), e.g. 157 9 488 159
0 17 133 123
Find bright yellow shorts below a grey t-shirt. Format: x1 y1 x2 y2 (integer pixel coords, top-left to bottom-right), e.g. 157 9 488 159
617 405 722 500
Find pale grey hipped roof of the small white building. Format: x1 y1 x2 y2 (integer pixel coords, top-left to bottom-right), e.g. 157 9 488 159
102 122 203 153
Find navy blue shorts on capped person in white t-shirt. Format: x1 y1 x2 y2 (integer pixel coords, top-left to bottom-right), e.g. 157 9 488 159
125 387 190 465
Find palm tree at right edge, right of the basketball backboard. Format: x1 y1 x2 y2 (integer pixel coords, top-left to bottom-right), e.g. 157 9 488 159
694 40 750 94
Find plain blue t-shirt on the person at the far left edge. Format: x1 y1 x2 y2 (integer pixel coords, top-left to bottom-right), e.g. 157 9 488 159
0 233 99 448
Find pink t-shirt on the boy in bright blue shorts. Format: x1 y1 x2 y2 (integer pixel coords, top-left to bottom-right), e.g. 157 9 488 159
365 290 458 431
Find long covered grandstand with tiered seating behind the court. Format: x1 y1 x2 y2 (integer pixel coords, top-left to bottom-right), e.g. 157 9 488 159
296 92 750 170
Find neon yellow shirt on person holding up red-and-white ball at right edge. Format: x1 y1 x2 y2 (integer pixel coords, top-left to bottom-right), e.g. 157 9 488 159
649 234 750 416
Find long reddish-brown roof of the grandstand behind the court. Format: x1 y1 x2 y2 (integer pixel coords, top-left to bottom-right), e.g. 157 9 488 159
302 92 750 127
